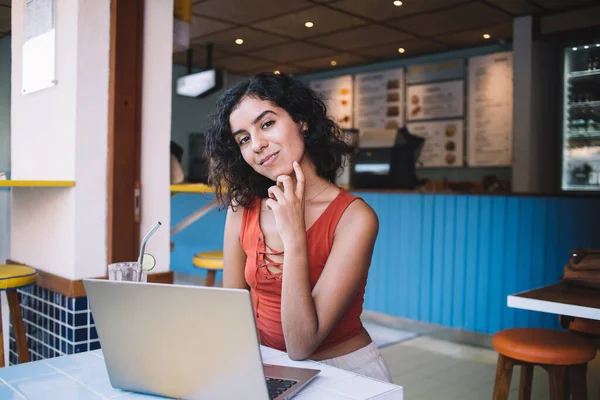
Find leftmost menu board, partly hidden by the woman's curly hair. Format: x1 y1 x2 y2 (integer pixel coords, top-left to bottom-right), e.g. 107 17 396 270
309 75 353 129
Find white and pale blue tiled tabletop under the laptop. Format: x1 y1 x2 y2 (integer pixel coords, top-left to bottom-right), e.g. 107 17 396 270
0 346 403 400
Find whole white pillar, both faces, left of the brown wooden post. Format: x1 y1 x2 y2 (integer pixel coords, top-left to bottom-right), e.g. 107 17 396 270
10 0 110 280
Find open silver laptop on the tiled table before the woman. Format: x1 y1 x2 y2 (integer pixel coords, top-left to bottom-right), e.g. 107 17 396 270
83 279 319 400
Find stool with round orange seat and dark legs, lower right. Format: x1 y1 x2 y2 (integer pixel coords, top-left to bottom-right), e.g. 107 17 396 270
492 328 596 400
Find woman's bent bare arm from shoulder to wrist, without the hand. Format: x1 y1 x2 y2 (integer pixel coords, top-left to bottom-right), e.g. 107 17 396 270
281 200 379 360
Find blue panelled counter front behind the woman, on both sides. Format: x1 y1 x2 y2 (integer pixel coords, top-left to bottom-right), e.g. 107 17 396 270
171 192 600 334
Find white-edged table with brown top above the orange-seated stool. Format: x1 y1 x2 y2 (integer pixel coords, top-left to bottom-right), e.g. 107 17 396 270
507 282 600 320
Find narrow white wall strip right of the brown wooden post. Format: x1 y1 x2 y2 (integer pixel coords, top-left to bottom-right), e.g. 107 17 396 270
140 0 173 272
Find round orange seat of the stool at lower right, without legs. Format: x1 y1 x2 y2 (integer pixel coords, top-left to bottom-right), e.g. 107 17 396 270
492 328 596 365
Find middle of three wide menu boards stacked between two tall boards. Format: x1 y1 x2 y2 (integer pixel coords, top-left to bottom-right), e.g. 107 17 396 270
406 80 464 121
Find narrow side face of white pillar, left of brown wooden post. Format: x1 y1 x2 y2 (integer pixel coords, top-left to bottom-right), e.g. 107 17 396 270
73 0 110 279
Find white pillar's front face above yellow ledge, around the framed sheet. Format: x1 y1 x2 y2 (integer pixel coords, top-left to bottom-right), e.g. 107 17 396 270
11 0 77 181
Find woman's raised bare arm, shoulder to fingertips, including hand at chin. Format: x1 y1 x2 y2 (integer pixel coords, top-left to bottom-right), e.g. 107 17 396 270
266 163 379 360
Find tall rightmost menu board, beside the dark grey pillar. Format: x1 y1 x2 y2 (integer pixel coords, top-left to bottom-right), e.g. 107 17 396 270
467 52 513 166
